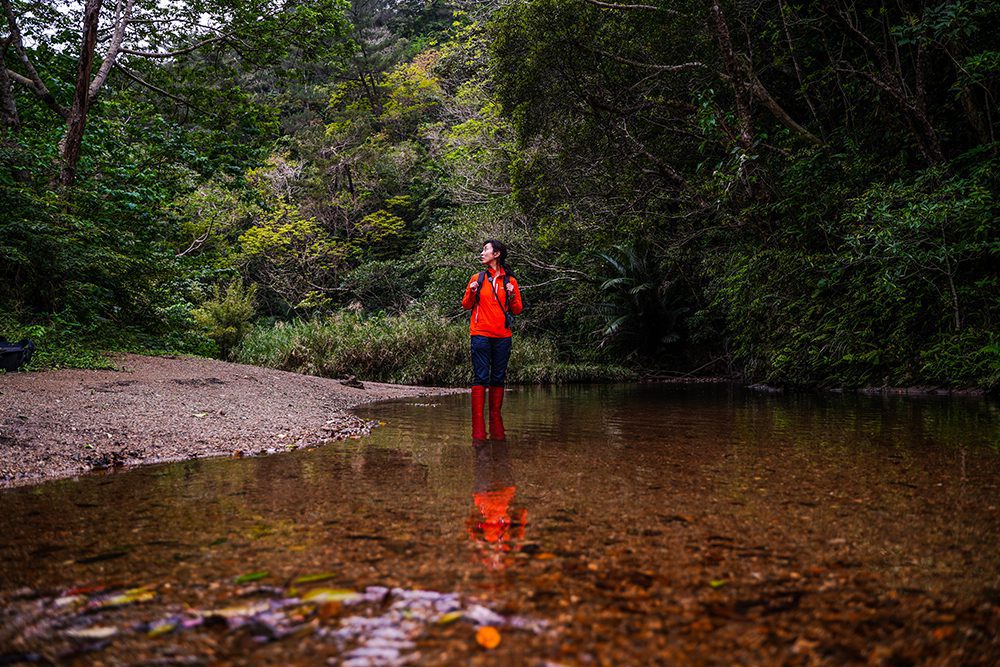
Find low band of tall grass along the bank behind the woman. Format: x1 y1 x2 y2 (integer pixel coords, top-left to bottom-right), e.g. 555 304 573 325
235 310 630 386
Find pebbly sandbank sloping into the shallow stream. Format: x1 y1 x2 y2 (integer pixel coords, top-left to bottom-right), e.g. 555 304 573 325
0 354 460 488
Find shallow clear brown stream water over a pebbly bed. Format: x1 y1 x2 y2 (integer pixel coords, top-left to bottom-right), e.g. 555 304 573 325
0 385 1000 665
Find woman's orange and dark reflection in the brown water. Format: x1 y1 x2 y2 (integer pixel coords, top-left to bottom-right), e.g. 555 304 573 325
466 442 528 570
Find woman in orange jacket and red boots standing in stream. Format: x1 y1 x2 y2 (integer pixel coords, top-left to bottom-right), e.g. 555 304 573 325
462 239 522 440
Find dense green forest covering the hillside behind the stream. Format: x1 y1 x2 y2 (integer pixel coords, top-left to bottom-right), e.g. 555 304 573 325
0 0 1000 388
